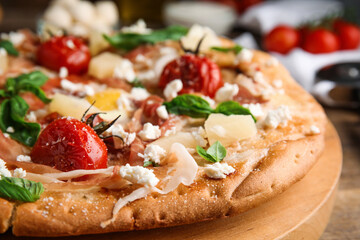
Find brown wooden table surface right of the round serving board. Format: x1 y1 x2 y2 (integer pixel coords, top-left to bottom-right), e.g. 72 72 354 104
320 108 360 240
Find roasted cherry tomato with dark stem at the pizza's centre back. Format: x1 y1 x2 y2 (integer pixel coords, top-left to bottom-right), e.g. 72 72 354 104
159 54 224 97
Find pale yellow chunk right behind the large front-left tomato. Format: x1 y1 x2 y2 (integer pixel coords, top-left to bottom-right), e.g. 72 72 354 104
49 93 100 120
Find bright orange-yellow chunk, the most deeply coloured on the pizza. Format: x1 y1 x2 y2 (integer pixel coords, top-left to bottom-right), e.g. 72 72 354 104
86 89 121 111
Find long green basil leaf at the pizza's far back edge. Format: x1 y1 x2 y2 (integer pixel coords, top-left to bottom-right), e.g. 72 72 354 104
104 26 188 51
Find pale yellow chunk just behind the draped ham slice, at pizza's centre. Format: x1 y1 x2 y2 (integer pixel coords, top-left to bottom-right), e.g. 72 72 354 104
149 132 197 153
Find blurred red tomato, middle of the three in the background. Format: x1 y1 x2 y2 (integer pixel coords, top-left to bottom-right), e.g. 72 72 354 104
302 28 340 53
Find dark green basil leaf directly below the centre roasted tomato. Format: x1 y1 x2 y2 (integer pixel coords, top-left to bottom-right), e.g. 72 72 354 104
163 94 213 118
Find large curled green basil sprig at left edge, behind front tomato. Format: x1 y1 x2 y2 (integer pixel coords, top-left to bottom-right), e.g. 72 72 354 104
0 71 50 146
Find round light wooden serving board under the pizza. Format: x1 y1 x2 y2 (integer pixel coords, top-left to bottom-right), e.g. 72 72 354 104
6 124 342 240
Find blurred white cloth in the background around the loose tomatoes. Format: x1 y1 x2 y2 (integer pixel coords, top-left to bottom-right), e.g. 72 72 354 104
234 0 360 92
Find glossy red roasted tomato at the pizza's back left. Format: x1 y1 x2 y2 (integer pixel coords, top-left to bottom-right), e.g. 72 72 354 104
37 36 91 74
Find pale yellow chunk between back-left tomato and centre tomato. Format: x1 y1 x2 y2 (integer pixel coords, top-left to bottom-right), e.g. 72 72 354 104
88 52 123 79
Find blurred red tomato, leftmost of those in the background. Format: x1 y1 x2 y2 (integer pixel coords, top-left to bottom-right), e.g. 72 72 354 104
264 25 300 54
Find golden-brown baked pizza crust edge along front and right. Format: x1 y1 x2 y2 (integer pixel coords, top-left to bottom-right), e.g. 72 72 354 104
0 47 327 236
